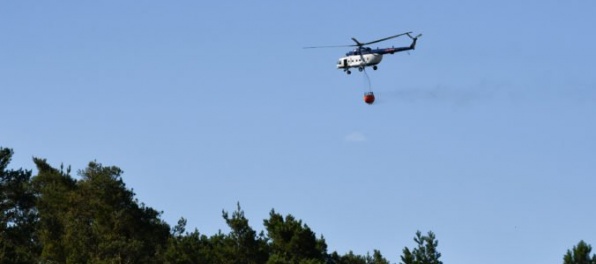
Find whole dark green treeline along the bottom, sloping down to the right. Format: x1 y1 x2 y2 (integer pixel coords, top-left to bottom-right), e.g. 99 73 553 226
0 147 596 264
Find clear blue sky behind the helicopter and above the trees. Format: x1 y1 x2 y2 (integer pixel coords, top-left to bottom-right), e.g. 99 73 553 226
0 0 596 264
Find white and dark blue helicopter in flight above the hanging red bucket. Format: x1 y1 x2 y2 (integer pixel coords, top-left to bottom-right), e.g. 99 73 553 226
304 32 422 75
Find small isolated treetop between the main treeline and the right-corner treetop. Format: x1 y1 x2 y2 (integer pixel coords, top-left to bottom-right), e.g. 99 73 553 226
401 231 443 264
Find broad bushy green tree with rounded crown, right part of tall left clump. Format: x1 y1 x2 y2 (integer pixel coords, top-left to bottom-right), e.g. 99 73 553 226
72 162 169 263
